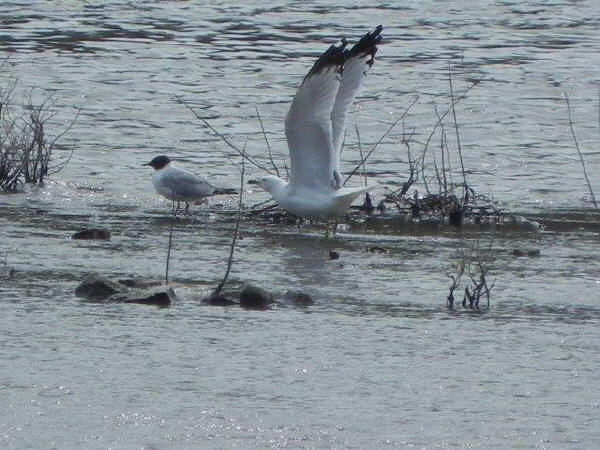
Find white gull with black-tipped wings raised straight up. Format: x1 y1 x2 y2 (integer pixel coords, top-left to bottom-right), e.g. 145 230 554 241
249 25 383 231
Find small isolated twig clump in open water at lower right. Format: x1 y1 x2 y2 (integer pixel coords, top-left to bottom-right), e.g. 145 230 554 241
446 239 495 309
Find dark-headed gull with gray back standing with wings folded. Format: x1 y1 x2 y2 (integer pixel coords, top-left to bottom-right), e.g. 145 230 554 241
142 155 237 214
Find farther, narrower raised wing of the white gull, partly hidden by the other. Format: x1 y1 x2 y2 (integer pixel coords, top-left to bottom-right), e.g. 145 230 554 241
331 25 383 163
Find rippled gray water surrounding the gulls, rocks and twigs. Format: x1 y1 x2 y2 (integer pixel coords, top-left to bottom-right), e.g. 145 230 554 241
0 0 600 449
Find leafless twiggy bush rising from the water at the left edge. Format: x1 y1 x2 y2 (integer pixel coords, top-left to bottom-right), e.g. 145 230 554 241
0 59 81 192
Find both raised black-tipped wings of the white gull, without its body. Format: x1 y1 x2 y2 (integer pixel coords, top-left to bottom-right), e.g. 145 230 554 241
285 25 382 191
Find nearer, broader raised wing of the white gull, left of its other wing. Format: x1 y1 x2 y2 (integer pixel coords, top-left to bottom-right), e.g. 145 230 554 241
285 42 346 190
